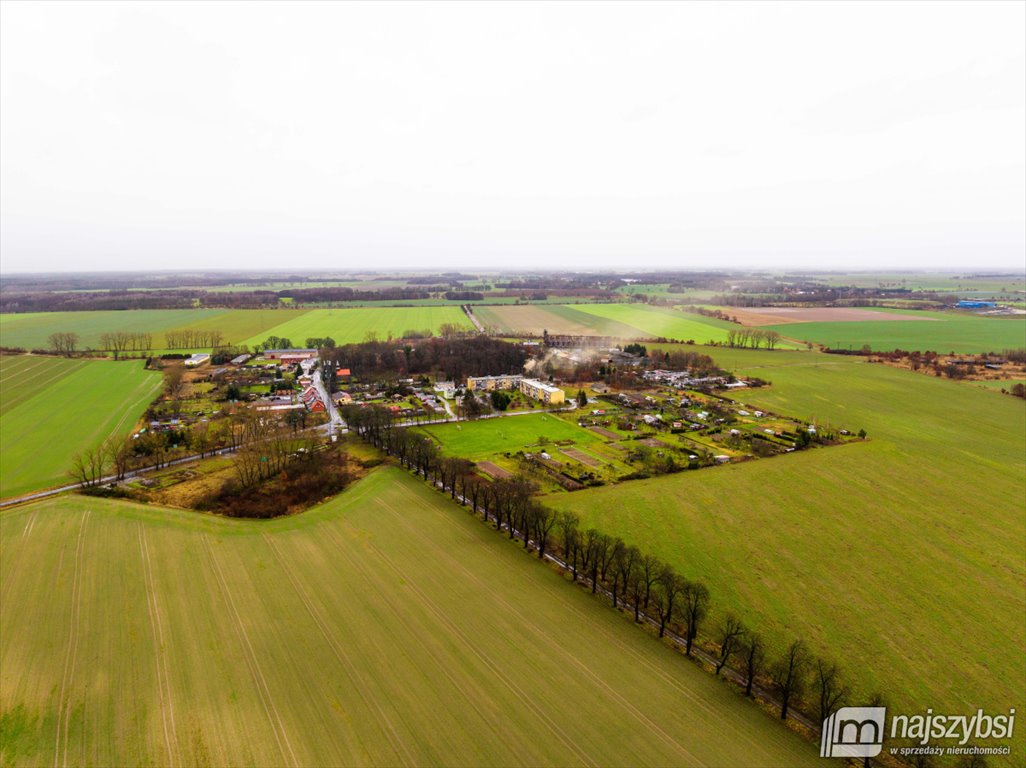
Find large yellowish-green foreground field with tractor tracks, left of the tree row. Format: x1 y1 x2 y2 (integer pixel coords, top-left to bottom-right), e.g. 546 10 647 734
0 468 818 766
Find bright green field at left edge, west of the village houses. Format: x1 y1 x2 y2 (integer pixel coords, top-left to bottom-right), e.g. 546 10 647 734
0 356 161 497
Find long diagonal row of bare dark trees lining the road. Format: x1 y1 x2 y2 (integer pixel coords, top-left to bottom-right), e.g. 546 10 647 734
342 405 882 754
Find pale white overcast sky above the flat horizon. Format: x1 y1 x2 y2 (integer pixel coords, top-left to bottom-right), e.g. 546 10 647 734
0 0 1026 272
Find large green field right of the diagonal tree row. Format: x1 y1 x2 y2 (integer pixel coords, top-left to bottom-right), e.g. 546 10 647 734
548 346 1026 749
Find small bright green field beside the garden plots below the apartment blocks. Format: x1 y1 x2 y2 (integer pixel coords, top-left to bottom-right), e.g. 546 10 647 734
421 413 602 459
